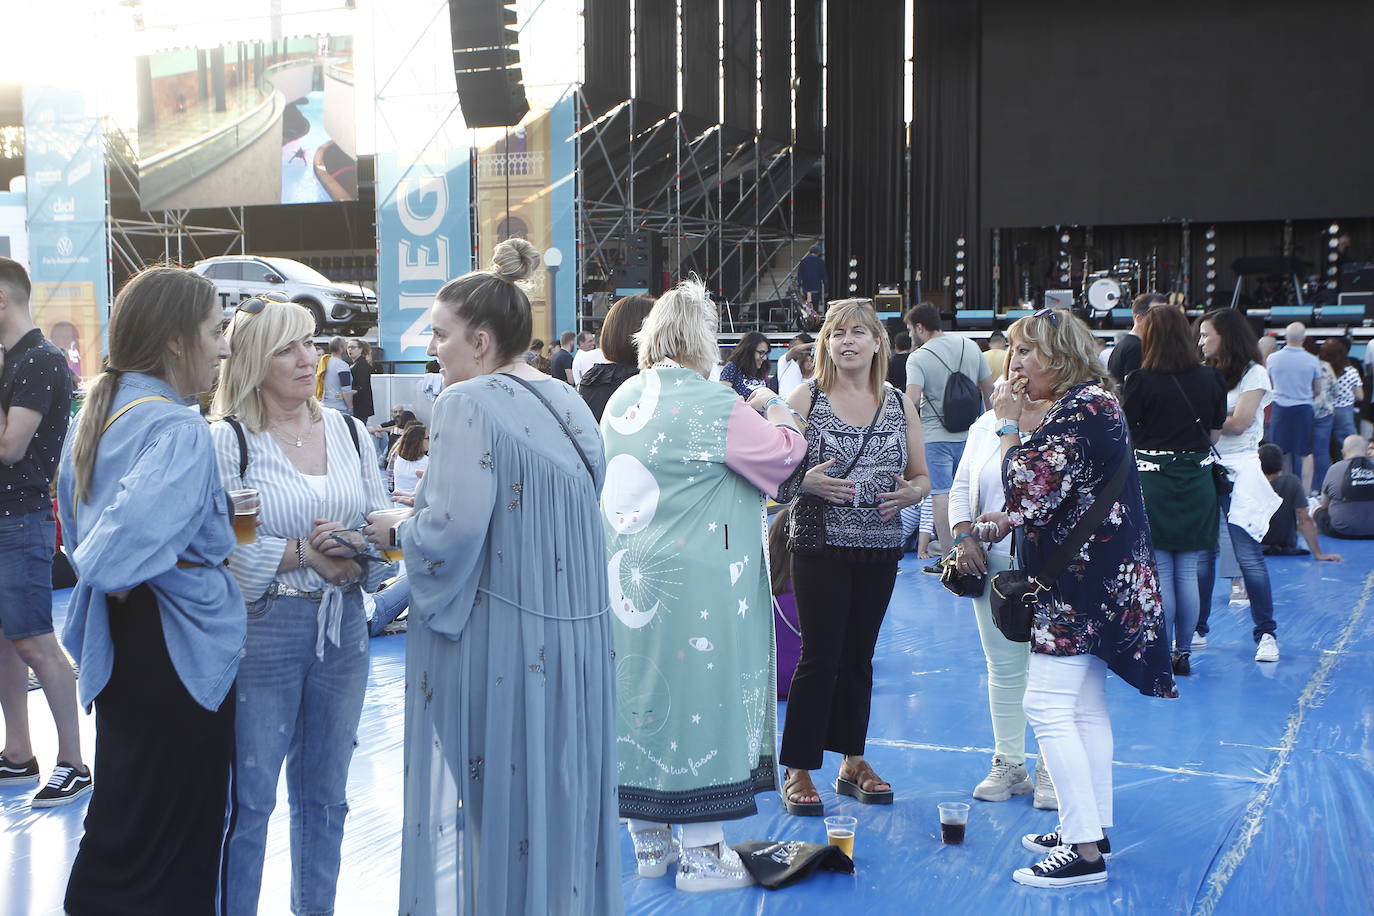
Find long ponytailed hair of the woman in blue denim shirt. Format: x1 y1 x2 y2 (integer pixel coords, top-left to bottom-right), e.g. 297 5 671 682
71 266 218 503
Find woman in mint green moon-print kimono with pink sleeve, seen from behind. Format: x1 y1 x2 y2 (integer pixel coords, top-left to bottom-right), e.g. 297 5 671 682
602 282 805 890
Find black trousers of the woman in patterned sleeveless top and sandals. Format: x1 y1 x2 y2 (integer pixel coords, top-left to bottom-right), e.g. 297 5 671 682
780 556 897 769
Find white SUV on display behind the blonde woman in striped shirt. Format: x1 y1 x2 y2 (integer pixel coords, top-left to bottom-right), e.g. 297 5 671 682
191 254 376 335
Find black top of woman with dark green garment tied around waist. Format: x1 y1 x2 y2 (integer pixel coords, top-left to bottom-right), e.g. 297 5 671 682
1121 365 1226 452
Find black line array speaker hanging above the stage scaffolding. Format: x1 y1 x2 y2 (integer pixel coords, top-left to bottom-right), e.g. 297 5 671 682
448 0 529 128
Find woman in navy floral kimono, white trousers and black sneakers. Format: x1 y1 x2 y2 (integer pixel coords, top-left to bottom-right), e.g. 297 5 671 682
980 309 1178 887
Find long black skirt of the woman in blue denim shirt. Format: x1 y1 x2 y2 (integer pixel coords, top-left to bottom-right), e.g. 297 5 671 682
66 585 235 916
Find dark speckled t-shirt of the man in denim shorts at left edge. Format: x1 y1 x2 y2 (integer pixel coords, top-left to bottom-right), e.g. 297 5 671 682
0 328 71 516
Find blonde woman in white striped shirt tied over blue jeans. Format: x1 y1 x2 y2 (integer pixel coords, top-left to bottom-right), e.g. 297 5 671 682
212 298 390 913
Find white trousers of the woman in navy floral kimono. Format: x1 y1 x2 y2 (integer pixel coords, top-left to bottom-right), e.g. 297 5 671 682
1024 652 1113 843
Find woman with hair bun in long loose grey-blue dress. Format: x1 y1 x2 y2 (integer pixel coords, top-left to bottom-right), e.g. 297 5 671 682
367 239 624 916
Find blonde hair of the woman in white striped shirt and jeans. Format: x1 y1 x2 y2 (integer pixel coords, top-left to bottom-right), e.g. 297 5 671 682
210 299 322 433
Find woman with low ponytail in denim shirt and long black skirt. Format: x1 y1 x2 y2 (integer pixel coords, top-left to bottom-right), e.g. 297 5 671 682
57 268 243 916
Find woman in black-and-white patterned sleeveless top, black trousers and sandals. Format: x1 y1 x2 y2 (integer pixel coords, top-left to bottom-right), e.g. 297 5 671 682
779 299 930 814
